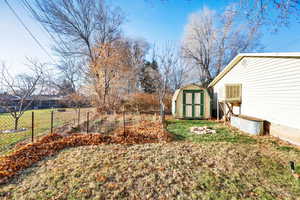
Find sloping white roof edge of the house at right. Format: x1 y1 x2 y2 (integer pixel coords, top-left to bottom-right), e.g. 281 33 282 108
208 52 300 87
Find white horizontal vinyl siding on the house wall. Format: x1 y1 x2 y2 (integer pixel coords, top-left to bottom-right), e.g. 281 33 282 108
214 57 300 129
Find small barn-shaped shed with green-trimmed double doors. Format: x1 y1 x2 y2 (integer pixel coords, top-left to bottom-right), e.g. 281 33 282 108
172 84 211 119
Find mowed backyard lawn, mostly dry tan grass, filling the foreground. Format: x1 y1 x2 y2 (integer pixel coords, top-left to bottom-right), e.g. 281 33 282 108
0 120 300 199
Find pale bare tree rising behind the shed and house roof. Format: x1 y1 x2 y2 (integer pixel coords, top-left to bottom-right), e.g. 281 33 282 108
182 7 260 86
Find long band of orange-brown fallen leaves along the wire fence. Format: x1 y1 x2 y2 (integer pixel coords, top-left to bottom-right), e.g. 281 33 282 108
0 121 172 184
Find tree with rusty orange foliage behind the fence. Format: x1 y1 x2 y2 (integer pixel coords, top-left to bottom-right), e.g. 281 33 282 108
90 39 147 110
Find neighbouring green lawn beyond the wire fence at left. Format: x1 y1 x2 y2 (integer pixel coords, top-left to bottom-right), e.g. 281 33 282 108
0 108 94 155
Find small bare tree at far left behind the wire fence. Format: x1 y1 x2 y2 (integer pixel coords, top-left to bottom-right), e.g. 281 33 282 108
0 62 44 130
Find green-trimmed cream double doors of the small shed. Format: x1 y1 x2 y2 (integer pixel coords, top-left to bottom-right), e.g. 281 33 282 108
183 90 204 118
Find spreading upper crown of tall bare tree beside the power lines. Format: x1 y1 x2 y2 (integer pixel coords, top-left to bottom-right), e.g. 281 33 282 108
22 0 124 62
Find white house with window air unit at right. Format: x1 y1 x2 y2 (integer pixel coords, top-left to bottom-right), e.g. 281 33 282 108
209 53 300 145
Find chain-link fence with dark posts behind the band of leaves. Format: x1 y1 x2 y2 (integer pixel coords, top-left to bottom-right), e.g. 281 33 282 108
0 108 158 155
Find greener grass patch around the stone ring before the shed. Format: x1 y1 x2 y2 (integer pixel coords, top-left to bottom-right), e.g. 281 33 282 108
168 120 256 144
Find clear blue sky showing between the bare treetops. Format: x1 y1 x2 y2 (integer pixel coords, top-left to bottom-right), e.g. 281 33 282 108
0 0 300 73
